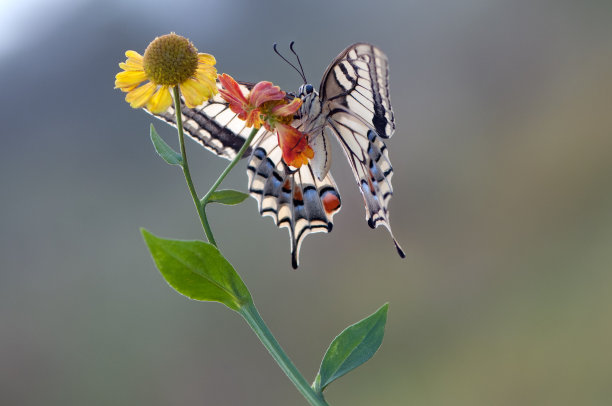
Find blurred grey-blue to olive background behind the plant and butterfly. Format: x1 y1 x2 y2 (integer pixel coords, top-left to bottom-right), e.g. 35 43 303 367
0 0 612 406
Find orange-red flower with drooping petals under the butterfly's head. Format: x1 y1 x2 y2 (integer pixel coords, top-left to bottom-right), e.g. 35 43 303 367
219 73 314 168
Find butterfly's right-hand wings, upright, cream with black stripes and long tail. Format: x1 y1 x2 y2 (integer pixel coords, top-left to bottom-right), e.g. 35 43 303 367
319 43 405 257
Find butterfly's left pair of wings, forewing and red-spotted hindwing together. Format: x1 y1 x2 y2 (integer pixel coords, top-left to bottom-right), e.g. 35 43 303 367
146 82 341 268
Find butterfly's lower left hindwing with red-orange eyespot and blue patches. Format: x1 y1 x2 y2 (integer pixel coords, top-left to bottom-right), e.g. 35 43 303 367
247 132 341 269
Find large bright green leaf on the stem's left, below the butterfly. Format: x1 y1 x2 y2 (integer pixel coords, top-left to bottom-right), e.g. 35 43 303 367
141 228 252 311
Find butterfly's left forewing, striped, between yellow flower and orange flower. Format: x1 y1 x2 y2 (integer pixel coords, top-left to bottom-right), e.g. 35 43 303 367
154 81 263 160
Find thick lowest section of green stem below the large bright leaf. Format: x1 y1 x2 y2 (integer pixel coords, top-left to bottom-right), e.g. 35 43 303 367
238 302 329 406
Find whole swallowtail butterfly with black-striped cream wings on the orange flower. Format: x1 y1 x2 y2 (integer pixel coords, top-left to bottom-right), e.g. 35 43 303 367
155 43 405 269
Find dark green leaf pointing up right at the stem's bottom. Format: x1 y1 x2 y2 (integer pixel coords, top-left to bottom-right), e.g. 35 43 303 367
313 303 389 393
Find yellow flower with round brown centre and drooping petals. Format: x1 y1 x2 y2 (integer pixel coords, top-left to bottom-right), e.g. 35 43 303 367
115 33 218 113
